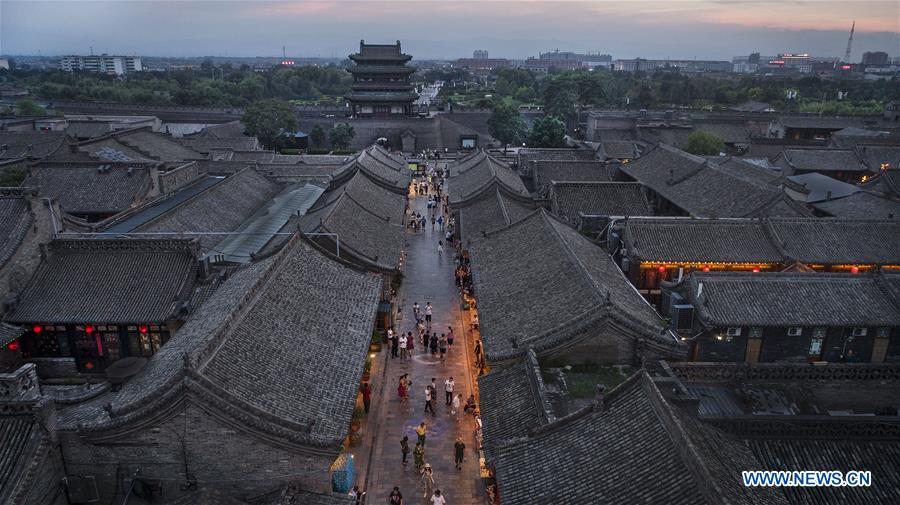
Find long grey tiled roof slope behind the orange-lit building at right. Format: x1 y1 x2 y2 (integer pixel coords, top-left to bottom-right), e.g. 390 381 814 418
622 144 810 217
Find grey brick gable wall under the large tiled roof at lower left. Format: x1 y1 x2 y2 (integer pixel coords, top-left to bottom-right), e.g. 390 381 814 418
60 404 336 503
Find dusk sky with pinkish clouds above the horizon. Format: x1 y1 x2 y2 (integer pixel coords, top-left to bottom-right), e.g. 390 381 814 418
0 0 900 61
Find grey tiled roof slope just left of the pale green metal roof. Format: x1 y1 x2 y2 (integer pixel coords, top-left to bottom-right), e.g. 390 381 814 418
134 168 281 250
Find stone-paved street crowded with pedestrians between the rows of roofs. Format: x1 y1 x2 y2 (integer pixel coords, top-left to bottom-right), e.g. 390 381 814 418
357 174 484 505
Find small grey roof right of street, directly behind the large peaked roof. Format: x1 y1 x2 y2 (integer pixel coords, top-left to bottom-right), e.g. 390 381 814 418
456 185 535 241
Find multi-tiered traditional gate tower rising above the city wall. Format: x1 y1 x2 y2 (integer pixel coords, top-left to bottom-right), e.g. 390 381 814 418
346 40 418 117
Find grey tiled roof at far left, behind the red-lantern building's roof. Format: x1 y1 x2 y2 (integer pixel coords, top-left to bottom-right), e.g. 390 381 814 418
25 162 152 214
